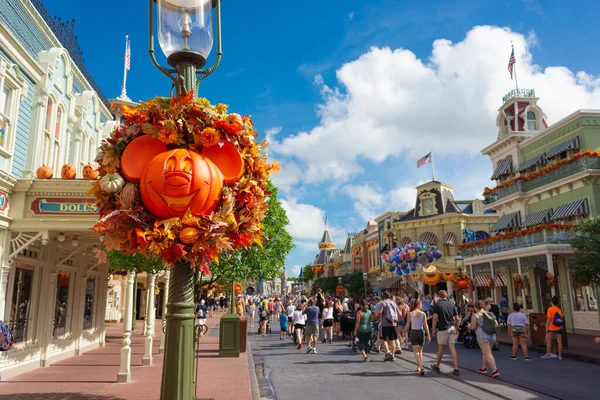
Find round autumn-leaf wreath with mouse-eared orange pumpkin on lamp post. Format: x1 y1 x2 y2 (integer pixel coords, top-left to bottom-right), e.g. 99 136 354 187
90 93 278 274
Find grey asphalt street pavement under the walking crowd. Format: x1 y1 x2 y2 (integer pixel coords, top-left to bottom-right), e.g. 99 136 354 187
250 330 600 400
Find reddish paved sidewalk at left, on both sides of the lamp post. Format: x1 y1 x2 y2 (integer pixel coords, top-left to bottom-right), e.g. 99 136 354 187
0 313 252 400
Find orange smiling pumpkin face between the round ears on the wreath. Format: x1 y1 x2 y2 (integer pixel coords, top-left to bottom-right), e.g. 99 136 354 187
140 149 223 219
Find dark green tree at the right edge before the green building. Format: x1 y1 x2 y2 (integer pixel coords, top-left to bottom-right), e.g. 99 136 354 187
569 217 600 284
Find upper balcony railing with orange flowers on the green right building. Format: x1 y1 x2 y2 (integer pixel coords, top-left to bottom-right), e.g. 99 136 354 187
485 157 600 204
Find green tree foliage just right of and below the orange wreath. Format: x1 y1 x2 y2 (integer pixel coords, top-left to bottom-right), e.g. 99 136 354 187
201 181 294 283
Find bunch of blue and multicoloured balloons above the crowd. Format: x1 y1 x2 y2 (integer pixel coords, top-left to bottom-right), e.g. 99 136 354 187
381 242 442 276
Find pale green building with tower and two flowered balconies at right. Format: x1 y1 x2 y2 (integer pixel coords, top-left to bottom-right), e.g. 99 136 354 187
461 89 600 334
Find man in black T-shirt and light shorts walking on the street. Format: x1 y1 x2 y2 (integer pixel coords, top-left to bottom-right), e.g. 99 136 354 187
431 290 460 376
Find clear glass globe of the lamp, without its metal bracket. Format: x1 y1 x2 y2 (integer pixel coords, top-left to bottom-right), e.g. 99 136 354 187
156 0 213 68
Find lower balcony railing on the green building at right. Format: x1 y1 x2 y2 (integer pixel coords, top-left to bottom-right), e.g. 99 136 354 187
460 230 575 258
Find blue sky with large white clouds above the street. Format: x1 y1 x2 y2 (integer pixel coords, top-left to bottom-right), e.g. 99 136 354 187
44 0 600 276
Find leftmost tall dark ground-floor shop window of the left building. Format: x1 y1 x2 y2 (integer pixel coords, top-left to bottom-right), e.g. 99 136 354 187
8 268 33 343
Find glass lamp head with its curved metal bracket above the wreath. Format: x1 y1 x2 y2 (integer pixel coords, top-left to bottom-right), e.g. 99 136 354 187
148 0 223 96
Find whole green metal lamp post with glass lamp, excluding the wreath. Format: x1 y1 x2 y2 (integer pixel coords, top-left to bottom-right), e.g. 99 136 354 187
148 0 222 400
